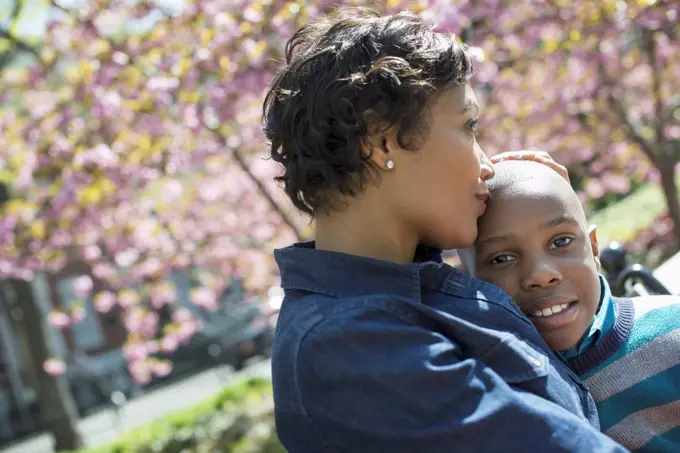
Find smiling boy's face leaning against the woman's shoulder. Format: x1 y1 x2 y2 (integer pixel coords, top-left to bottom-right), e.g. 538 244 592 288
466 173 601 351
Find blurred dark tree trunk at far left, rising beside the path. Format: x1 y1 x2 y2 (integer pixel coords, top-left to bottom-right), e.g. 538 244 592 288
10 280 83 451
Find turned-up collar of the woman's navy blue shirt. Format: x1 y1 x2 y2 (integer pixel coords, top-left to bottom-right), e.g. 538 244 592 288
274 241 444 301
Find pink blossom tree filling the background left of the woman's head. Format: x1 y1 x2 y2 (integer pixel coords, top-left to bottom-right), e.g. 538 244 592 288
0 0 317 449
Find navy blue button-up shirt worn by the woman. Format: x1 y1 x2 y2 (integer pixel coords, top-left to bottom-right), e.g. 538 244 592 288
272 243 626 453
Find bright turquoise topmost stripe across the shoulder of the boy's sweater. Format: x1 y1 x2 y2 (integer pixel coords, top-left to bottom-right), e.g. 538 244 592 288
581 304 680 380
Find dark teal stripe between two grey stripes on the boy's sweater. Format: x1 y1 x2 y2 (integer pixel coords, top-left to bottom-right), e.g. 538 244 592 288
597 358 680 430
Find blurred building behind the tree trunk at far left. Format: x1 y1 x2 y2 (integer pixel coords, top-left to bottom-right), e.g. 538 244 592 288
0 266 134 442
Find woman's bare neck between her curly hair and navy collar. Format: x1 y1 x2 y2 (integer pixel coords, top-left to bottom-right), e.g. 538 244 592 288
316 206 418 264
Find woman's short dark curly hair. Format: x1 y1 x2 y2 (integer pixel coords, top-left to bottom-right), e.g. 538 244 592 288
263 9 473 216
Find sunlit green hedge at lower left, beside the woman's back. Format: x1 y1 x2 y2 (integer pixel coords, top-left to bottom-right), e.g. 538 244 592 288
65 378 286 453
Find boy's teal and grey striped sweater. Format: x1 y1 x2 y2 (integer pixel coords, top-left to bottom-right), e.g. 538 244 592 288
568 296 680 453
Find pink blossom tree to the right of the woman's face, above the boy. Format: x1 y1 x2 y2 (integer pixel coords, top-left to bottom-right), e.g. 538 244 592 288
423 0 680 247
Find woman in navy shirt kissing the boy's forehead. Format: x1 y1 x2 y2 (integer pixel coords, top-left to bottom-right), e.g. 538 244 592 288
264 7 625 453
